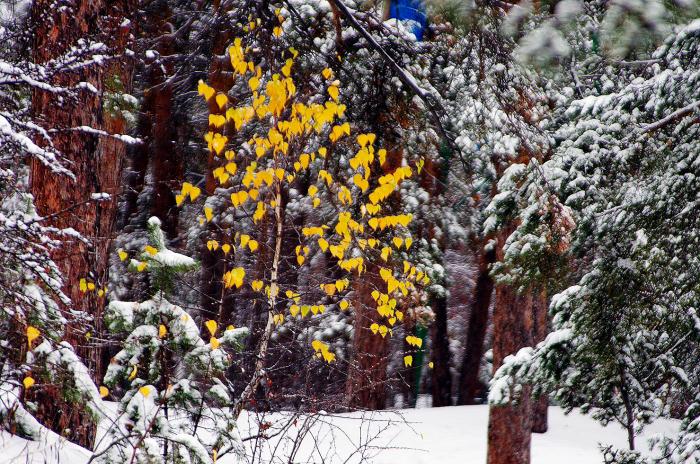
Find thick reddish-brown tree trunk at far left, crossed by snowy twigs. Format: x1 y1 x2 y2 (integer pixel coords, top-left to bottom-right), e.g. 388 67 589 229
30 0 133 446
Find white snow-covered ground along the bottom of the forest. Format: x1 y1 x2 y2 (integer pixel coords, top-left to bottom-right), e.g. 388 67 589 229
0 406 677 464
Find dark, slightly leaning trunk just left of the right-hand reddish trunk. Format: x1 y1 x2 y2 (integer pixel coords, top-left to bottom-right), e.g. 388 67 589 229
457 243 496 404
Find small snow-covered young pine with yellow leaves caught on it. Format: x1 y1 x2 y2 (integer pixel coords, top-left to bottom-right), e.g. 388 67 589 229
96 217 248 463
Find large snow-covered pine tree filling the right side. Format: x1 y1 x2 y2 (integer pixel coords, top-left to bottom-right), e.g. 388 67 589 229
491 12 700 463
